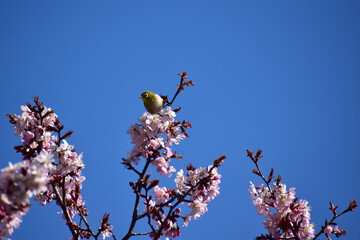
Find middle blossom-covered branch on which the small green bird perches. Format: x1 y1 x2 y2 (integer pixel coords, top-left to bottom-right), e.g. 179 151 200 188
123 72 225 240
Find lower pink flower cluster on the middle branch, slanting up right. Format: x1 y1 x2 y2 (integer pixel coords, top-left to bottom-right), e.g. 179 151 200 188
143 160 221 239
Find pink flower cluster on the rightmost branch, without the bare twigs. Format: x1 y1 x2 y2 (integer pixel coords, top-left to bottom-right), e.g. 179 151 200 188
249 181 315 240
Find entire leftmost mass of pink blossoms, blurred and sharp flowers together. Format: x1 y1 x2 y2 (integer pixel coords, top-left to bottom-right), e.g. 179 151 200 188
4 97 111 240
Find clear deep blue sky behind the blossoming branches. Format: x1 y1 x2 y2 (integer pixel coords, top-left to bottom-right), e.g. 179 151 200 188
0 0 360 240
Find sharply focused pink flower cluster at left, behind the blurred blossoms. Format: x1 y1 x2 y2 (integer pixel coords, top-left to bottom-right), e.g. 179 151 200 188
10 99 85 216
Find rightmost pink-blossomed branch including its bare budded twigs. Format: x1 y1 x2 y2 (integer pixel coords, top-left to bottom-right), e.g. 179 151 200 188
247 150 357 240
